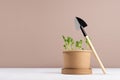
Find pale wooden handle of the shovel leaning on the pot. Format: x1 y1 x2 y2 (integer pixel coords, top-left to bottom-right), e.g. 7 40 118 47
86 36 106 74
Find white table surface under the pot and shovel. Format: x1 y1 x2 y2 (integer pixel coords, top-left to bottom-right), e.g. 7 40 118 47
0 68 120 80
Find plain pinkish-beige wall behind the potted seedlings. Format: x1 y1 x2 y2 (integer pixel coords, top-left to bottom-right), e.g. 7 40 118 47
0 0 120 67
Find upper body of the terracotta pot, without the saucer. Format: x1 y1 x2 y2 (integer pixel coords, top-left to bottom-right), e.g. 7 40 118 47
63 50 91 69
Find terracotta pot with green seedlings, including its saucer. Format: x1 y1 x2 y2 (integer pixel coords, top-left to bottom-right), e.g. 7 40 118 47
62 36 92 74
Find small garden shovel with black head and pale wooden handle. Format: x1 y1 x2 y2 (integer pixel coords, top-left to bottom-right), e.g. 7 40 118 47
76 17 106 74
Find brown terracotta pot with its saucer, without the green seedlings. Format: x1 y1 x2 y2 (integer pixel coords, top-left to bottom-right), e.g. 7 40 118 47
62 50 92 74
